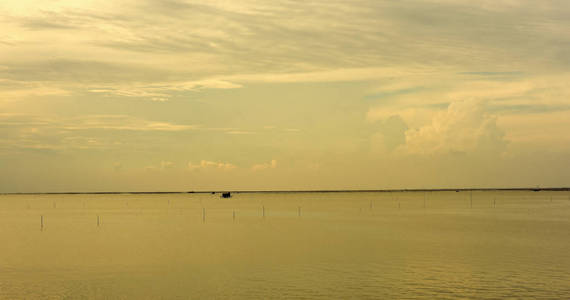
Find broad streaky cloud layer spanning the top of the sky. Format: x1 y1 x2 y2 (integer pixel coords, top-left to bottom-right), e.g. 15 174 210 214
0 0 570 98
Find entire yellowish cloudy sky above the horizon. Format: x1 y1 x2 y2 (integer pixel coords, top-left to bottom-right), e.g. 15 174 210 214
0 0 570 192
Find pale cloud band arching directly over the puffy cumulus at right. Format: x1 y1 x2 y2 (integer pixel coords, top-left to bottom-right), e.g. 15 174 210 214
366 71 570 133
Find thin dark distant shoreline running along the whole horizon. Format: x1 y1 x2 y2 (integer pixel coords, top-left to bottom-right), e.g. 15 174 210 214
0 187 570 195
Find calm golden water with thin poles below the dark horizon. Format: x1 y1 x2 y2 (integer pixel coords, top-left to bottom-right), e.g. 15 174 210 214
0 192 570 299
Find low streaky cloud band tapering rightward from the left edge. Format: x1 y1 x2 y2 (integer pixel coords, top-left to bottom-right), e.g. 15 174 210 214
0 113 200 151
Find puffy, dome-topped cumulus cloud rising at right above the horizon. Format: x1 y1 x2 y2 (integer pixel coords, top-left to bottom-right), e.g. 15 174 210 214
404 100 506 154
